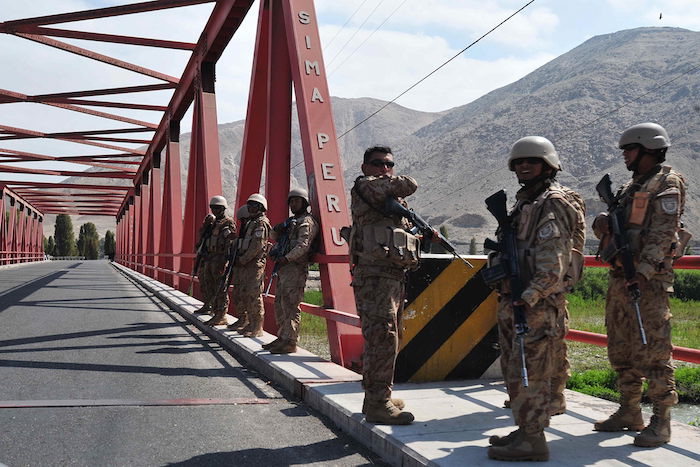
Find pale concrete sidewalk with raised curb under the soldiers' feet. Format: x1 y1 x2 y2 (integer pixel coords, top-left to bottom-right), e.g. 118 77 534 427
113 263 700 467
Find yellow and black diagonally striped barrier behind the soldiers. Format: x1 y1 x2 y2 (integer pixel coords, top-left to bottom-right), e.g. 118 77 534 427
395 255 500 382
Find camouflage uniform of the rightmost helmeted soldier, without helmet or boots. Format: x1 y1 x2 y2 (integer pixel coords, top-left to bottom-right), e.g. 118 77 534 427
596 165 685 414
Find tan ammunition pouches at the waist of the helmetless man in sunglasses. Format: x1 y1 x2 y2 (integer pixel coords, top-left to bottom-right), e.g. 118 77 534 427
360 222 420 269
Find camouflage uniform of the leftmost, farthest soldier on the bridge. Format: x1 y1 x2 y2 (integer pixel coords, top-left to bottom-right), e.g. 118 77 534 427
199 216 236 317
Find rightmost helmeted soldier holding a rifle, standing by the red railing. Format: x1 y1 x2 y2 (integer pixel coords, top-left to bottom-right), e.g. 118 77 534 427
593 123 689 447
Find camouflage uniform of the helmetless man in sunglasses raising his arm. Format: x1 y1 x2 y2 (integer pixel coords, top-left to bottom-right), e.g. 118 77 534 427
350 175 418 404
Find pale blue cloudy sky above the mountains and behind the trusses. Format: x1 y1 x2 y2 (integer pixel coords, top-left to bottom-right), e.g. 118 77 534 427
0 0 700 186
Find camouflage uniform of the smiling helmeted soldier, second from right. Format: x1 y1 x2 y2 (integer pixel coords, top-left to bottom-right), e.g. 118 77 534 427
498 181 580 433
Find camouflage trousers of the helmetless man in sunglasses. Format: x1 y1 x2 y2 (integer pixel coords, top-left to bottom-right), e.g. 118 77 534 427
352 276 405 402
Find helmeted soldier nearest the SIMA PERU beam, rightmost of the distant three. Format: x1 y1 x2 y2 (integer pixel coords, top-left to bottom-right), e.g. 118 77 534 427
262 188 318 354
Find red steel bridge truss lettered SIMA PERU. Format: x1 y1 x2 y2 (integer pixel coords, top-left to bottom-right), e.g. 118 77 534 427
0 0 698 366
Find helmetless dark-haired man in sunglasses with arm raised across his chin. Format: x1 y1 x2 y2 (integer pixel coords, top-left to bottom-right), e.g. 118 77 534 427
350 147 418 425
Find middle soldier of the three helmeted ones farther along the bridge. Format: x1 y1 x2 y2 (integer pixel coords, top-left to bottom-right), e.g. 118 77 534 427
232 193 270 337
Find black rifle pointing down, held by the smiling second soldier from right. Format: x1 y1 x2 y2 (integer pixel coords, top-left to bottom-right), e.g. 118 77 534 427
481 190 530 387
